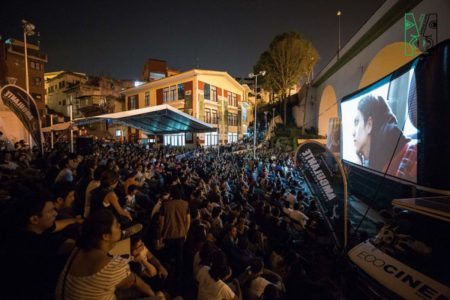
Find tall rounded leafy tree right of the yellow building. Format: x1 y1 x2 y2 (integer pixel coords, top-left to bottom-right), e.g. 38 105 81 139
254 32 319 125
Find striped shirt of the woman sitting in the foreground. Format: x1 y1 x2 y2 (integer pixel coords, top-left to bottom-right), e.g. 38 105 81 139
56 251 131 300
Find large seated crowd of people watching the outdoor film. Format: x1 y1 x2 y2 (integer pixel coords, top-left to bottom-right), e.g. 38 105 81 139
0 142 340 300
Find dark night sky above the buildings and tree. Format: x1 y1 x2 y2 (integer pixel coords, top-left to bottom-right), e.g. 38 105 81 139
0 0 384 80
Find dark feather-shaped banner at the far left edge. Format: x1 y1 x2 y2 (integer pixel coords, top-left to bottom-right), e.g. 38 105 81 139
0 84 44 154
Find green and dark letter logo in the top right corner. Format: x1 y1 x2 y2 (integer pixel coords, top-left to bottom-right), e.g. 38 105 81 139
403 13 437 56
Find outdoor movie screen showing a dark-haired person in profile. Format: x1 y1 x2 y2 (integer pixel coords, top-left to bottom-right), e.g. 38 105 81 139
340 64 418 183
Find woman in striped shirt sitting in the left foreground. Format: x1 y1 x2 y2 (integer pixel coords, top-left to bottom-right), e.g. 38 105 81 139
56 209 163 300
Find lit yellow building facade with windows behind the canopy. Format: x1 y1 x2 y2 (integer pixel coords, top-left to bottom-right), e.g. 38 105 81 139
123 69 251 146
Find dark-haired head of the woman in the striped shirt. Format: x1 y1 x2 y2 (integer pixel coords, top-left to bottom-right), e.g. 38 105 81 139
78 209 121 250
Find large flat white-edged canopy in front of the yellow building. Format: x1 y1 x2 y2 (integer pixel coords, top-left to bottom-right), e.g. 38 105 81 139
73 104 217 134
